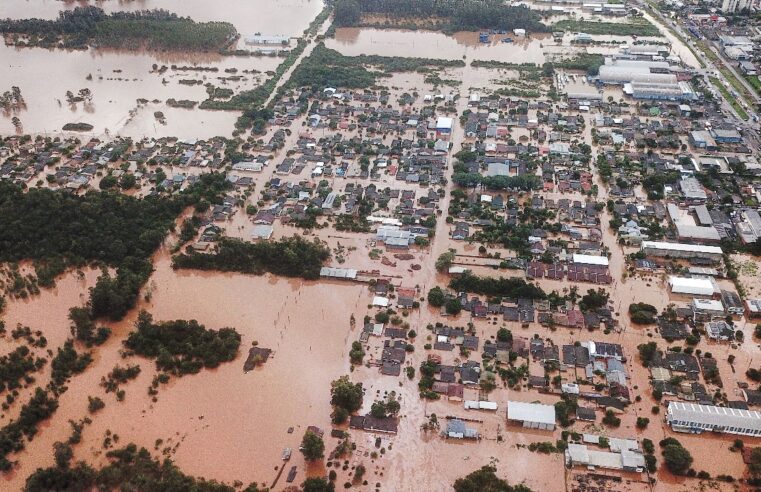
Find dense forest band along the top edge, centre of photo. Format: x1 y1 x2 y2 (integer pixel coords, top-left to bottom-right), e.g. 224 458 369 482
335 0 548 32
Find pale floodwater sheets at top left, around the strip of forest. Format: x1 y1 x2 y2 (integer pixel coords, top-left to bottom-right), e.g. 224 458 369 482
0 0 323 138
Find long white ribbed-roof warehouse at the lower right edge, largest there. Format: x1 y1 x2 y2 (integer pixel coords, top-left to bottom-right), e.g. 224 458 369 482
666 401 761 436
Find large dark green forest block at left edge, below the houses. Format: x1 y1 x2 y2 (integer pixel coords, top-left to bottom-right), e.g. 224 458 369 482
0 174 230 319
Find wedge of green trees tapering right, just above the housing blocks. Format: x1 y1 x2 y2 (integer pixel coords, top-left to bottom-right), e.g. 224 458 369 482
288 44 465 89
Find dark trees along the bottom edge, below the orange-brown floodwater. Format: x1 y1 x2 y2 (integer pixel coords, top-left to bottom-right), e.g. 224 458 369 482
24 444 259 492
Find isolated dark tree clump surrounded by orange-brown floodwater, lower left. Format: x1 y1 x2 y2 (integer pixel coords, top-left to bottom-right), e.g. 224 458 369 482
124 311 240 376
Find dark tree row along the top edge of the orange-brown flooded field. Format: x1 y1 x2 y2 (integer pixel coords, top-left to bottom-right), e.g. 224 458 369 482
172 236 330 280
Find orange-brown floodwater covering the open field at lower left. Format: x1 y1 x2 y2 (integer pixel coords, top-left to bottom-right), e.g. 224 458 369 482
5 254 366 490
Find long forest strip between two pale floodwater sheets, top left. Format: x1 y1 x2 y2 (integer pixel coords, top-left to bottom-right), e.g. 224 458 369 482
0 6 238 51
